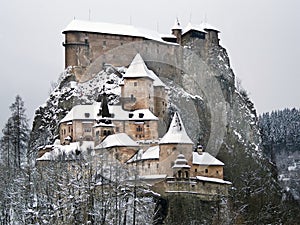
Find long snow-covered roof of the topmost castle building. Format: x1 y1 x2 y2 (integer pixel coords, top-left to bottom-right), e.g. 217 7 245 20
63 20 170 44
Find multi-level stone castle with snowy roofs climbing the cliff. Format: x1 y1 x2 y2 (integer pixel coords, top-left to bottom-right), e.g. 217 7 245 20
37 18 231 200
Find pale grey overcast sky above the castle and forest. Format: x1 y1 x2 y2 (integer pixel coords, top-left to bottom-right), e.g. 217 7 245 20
0 0 300 128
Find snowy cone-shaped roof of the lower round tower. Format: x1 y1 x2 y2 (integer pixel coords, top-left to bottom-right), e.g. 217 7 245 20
159 112 193 144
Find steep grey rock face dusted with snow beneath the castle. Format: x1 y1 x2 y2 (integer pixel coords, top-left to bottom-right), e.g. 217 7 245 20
31 40 296 224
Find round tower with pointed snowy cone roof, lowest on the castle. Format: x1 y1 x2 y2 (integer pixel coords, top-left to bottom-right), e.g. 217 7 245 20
159 112 194 176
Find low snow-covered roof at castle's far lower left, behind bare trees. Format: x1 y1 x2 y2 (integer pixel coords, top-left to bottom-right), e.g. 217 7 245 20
37 141 94 161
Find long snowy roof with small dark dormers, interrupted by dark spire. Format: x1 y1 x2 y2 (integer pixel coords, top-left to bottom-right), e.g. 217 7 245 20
60 103 158 123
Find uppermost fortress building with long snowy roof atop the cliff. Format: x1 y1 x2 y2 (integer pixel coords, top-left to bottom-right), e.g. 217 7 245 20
63 20 219 82
